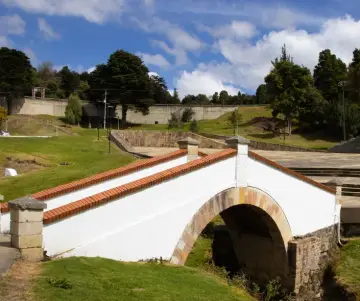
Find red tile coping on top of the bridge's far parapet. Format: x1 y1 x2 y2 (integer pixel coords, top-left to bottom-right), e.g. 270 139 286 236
0 149 187 213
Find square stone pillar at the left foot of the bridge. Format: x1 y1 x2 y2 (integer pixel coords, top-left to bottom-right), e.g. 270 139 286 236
9 197 47 262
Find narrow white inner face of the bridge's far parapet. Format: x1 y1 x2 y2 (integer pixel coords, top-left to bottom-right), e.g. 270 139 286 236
0 155 187 233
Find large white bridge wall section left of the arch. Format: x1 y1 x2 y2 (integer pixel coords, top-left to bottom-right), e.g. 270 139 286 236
44 157 235 261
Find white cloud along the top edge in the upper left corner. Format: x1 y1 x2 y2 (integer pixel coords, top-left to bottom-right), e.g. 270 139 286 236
0 0 124 23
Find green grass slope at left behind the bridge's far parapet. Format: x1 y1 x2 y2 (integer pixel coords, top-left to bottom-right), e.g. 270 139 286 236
0 127 134 201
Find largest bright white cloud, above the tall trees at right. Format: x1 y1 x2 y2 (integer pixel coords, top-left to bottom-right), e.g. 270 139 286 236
177 16 360 92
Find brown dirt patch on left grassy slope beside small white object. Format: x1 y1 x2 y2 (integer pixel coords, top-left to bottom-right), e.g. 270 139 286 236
0 156 49 178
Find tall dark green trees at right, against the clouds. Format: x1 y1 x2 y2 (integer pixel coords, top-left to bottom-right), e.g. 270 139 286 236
258 45 360 140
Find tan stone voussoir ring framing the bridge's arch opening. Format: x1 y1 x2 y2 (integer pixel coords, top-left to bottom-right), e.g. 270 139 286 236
171 187 292 265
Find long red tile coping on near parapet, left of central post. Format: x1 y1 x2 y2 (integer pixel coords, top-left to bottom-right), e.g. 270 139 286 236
44 149 236 224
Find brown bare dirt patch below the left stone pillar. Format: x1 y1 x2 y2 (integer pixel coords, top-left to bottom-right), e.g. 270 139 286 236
0 260 41 301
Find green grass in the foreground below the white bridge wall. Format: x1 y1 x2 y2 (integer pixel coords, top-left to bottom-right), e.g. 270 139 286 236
33 257 253 301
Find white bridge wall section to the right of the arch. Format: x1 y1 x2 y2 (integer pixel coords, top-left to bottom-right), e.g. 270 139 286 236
247 158 336 236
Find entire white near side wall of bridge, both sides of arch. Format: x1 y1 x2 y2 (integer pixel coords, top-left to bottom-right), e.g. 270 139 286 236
44 152 336 261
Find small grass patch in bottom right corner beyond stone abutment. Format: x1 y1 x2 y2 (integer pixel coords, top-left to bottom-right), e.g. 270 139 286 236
335 239 360 300
